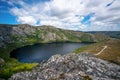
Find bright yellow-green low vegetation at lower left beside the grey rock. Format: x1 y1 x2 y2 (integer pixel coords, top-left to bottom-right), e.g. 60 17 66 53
0 59 37 79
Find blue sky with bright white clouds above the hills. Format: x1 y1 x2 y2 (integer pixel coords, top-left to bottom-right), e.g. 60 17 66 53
0 0 120 31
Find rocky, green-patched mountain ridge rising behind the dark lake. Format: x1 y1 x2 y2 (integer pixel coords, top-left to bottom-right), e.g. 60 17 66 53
0 24 109 57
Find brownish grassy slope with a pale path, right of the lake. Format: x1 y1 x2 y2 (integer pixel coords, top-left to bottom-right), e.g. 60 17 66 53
74 39 120 64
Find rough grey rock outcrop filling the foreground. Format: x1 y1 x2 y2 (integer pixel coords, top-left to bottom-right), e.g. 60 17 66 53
9 53 120 80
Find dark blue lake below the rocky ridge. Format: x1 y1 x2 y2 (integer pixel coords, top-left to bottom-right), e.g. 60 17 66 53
10 43 90 63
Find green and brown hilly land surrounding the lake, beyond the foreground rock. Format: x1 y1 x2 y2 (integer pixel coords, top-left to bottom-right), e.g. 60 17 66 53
0 24 120 79
